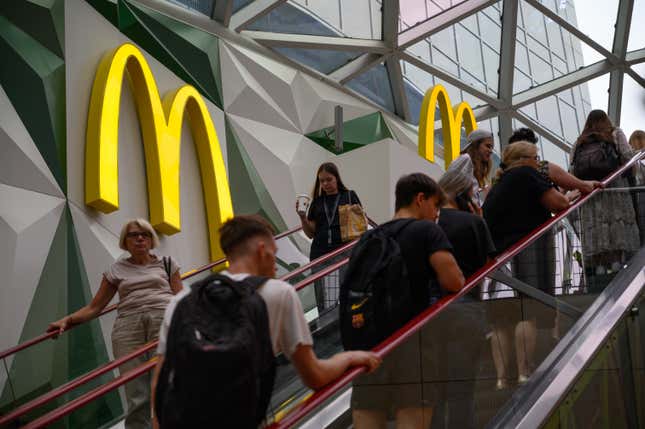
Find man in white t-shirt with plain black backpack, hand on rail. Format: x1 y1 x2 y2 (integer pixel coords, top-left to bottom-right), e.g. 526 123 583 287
152 216 380 428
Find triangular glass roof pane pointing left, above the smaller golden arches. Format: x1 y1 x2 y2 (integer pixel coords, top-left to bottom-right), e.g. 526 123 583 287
407 2 501 94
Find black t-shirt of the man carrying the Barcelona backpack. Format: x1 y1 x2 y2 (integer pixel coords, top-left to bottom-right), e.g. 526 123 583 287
379 219 452 314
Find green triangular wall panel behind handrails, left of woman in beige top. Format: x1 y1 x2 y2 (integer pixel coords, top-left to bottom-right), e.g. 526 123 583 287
0 209 123 428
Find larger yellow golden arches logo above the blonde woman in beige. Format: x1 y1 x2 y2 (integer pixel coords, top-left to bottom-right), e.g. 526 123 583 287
85 43 233 259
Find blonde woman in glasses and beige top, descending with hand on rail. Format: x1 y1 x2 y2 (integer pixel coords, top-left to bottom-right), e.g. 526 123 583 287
47 219 182 429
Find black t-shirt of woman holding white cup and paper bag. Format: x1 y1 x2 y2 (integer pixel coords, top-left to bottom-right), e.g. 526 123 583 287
307 191 362 259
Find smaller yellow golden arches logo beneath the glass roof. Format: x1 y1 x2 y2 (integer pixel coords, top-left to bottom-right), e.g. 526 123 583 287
419 85 477 169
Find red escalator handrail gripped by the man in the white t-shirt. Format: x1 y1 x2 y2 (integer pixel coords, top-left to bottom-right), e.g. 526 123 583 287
268 152 645 429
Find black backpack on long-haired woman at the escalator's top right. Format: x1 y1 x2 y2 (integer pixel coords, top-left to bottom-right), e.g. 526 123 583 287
572 136 620 180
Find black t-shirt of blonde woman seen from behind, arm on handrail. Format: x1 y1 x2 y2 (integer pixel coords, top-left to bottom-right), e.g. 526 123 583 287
482 166 552 252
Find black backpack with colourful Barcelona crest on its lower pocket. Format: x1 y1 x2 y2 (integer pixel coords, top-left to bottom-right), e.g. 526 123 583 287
339 219 414 350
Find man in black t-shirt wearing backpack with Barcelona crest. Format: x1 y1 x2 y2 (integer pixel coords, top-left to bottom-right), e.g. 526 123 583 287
340 173 464 429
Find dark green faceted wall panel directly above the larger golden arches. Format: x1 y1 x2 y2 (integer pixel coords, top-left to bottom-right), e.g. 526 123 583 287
118 0 223 108
